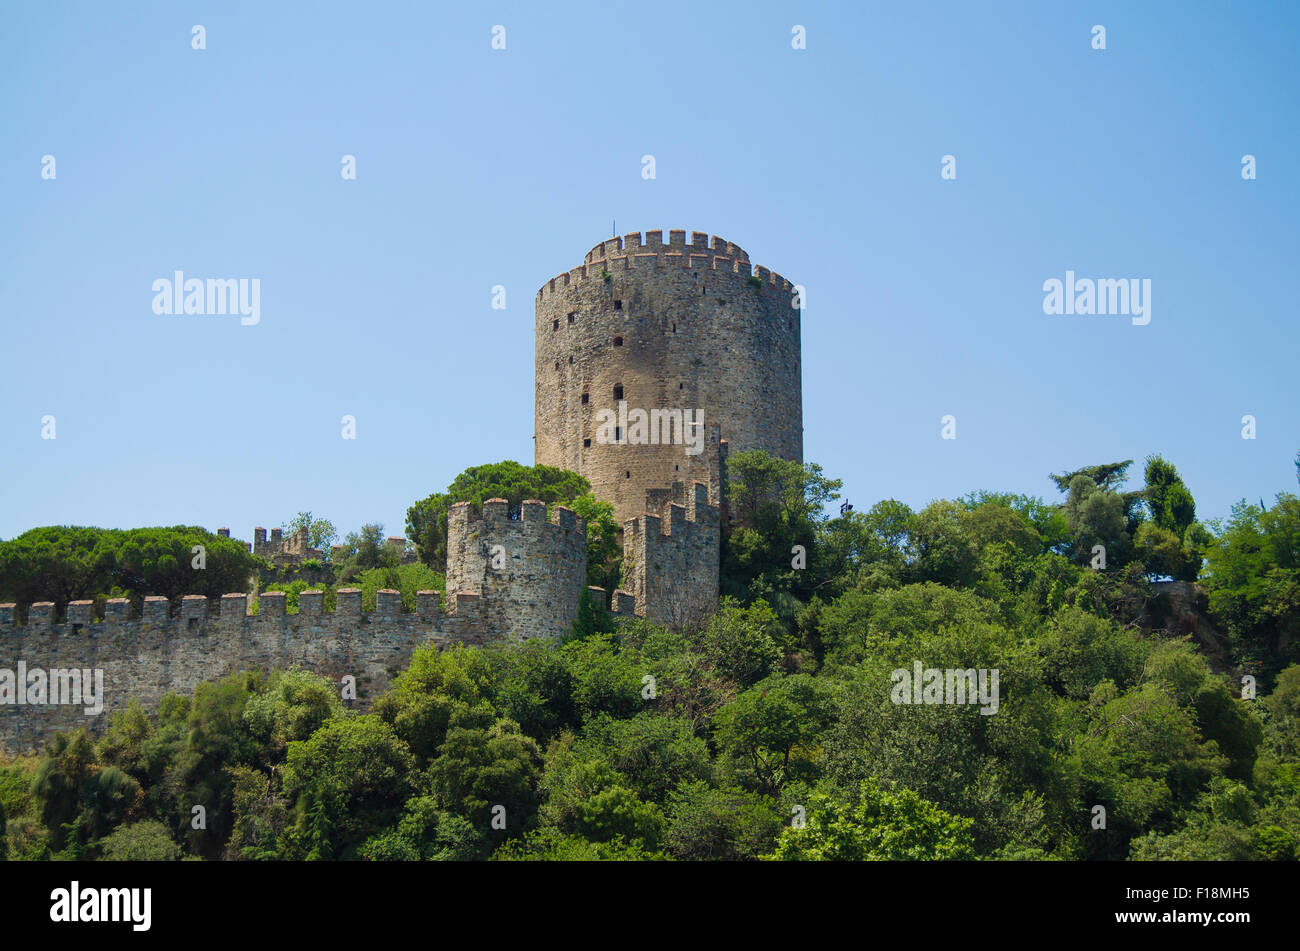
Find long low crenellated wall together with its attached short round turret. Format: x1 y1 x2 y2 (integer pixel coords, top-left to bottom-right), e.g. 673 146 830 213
0 499 590 754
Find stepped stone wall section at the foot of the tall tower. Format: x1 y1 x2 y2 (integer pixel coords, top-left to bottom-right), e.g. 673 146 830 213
615 482 720 626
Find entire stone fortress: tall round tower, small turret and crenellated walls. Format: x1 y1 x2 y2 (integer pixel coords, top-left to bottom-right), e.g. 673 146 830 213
0 231 803 754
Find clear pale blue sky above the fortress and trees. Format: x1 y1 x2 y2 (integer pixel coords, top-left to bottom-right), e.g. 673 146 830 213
0 3 1300 538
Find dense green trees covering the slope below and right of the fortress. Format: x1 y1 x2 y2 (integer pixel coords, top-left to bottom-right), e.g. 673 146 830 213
0 453 1300 861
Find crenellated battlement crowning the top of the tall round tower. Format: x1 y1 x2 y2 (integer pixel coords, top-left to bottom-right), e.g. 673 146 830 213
537 231 794 301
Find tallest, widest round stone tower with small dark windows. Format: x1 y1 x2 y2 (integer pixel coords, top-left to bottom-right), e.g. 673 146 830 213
534 231 803 525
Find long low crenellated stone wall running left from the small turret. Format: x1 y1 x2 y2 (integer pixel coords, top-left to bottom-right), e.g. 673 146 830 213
0 589 497 754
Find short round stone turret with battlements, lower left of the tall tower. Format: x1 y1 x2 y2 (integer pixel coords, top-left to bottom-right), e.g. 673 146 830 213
447 499 586 640
